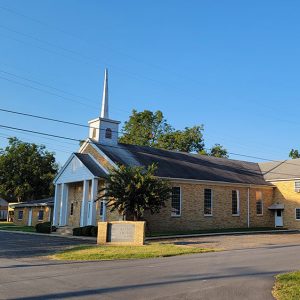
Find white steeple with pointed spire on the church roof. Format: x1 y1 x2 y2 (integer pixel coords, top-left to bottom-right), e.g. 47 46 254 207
89 69 120 145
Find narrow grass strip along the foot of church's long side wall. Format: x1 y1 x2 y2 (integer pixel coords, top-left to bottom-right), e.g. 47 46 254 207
146 227 285 237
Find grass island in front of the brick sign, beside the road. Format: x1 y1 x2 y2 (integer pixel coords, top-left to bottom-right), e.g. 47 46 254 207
51 243 218 260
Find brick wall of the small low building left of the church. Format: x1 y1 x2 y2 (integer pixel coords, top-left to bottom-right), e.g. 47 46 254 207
14 206 53 226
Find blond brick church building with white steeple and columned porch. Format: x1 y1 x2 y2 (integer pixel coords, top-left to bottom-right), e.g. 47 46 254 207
53 70 300 232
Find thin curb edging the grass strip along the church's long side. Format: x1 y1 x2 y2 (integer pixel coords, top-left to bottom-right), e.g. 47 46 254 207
145 229 300 241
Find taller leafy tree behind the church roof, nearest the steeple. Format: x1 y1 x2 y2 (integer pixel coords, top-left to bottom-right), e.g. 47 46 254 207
119 110 172 146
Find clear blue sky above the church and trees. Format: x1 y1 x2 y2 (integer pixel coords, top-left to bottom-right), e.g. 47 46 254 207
0 0 300 164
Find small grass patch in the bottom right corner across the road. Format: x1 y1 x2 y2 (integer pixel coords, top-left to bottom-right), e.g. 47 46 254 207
273 271 300 300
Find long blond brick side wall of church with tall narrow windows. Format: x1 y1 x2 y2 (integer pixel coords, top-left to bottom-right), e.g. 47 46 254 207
145 182 274 232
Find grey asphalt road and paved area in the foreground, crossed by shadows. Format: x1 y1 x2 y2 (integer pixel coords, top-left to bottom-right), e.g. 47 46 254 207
0 232 300 300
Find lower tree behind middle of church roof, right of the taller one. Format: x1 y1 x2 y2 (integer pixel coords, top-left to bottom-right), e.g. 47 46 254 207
156 126 204 152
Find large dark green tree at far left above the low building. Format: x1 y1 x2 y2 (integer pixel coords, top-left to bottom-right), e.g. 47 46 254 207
0 138 58 202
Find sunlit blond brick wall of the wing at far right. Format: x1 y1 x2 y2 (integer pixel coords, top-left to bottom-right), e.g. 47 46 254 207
272 180 300 229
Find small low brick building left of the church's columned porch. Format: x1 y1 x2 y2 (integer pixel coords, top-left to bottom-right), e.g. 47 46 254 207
9 197 54 226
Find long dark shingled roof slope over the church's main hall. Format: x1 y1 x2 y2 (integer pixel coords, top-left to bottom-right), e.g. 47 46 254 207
95 143 270 185
